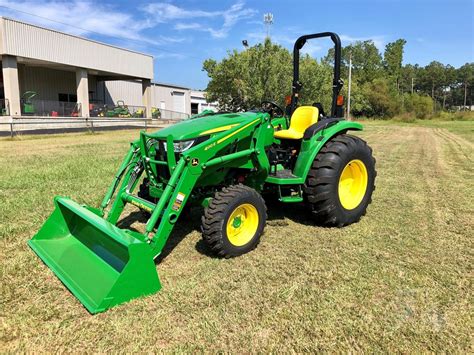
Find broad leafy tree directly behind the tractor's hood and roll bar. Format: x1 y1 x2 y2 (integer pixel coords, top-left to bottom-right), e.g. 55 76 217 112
203 38 332 111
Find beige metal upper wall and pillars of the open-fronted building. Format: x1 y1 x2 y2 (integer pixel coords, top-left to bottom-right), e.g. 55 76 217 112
0 18 153 117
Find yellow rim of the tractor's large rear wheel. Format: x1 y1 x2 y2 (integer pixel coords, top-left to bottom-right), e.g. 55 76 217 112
339 159 368 210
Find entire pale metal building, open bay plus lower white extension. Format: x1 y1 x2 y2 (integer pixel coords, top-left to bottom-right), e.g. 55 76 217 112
0 17 216 117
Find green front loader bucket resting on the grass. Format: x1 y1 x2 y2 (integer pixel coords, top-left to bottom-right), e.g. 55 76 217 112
28 197 161 313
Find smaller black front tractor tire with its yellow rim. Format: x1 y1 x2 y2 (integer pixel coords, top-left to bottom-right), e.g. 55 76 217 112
201 184 267 258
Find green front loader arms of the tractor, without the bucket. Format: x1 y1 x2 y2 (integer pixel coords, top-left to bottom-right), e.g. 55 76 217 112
102 114 273 257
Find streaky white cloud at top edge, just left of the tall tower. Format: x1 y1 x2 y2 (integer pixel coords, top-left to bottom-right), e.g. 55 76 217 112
149 0 257 38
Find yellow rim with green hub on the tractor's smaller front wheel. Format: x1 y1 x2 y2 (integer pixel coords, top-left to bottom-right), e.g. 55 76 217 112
226 203 259 247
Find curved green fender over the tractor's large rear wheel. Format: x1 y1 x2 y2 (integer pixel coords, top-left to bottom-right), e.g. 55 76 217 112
293 120 363 181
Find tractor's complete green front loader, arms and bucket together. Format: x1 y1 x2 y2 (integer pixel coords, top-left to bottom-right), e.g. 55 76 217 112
28 114 273 313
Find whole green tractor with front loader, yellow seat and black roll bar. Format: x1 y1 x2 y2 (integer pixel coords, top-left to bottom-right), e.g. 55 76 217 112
28 32 376 313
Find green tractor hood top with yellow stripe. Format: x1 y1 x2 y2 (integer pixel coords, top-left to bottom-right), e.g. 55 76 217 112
150 112 258 141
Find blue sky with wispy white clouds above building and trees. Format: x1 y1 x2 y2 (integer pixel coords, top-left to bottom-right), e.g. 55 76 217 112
0 0 474 89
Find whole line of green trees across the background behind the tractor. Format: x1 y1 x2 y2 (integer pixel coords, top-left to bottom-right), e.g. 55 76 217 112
203 38 474 118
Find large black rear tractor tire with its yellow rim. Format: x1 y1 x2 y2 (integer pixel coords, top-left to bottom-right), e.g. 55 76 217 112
304 134 377 227
